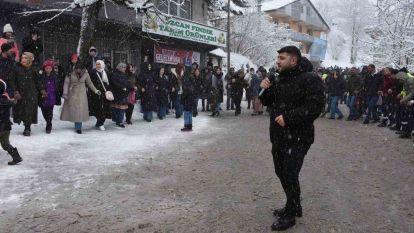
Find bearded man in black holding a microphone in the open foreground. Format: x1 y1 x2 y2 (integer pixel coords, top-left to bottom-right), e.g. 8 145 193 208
260 46 325 231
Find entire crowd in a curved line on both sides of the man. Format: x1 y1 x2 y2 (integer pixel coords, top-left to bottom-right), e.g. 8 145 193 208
0 21 414 165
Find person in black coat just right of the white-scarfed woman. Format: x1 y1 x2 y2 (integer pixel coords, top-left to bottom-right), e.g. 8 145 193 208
109 62 136 128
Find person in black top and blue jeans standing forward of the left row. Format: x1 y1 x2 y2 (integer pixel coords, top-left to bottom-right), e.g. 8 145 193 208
177 67 198 132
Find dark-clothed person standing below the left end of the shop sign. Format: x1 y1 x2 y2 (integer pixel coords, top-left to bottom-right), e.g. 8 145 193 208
137 62 157 122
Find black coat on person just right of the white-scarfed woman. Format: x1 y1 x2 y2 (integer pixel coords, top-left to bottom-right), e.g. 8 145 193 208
109 70 134 105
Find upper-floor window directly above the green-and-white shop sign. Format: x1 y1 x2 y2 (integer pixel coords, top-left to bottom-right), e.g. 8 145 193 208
158 0 192 19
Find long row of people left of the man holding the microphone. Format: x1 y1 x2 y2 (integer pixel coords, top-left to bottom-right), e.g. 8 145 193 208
0 24 267 165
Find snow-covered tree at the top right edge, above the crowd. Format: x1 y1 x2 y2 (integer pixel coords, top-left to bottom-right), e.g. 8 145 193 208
365 0 414 70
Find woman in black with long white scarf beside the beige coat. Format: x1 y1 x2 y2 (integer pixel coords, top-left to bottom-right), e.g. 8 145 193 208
88 60 112 131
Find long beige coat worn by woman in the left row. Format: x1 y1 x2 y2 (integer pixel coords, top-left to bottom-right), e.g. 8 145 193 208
60 70 98 122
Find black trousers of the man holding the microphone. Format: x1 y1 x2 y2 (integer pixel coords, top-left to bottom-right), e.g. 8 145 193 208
272 143 310 217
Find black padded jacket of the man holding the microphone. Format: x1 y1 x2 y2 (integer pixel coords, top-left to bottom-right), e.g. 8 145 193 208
260 68 325 145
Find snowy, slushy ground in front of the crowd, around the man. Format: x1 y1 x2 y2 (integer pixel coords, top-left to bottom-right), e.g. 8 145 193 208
0 101 414 233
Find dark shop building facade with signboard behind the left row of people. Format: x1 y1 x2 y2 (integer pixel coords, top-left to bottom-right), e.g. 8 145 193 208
0 0 226 71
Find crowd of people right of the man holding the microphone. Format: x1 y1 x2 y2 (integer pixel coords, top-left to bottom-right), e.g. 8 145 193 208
319 64 414 138
